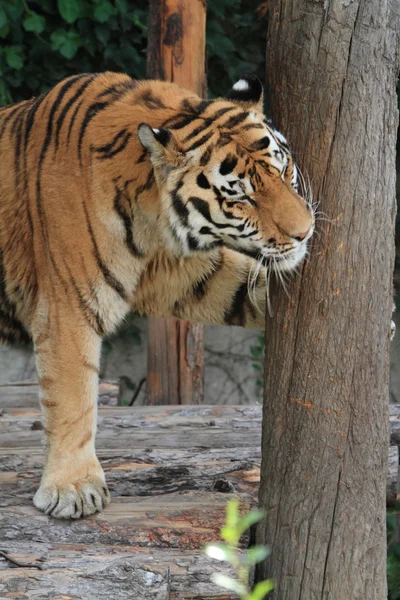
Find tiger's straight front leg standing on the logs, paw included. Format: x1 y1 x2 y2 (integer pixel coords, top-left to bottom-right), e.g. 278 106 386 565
32 303 110 519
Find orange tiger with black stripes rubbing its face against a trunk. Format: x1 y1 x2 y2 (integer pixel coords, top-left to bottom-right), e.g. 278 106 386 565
0 72 315 519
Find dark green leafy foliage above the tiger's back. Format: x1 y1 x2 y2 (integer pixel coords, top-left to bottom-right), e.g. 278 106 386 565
0 0 266 105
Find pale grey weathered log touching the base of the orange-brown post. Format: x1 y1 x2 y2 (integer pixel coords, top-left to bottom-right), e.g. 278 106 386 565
0 406 261 448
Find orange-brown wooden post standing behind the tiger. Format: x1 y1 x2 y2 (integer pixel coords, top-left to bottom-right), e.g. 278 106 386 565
147 0 206 404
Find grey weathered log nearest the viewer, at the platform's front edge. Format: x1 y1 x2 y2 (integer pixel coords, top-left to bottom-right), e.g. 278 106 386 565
0 541 233 600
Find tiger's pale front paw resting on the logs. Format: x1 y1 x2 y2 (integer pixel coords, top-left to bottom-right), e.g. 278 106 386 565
33 475 110 519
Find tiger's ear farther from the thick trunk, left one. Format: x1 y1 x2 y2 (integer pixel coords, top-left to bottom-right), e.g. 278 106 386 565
138 123 182 166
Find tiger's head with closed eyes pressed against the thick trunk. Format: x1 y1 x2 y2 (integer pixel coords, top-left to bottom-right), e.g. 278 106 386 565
138 75 314 271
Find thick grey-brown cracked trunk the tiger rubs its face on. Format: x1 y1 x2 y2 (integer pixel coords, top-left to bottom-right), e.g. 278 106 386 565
258 0 400 600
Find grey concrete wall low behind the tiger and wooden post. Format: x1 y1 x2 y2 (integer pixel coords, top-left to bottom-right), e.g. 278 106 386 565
0 312 400 404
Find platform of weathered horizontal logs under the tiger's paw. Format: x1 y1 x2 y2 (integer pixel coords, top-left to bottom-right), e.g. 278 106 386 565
0 383 400 600
